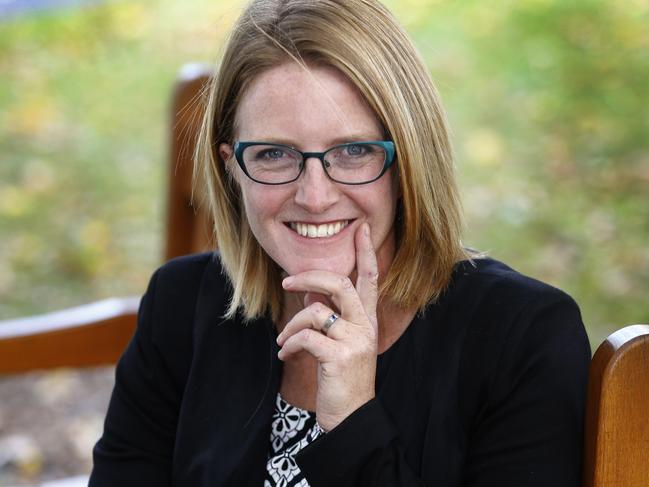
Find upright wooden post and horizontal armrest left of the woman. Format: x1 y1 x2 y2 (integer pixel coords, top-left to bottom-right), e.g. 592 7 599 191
0 64 214 374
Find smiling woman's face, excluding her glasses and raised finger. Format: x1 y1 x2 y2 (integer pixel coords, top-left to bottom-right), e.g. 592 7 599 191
219 62 398 276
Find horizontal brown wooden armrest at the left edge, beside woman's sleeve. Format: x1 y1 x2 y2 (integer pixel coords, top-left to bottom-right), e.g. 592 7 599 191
0 297 140 374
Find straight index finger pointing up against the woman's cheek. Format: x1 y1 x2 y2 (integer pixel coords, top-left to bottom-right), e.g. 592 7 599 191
354 223 379 327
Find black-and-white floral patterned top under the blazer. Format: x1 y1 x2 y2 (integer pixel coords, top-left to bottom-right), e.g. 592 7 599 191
264 393 324 487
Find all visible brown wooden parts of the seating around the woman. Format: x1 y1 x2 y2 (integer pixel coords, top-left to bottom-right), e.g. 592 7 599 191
0 65 649 487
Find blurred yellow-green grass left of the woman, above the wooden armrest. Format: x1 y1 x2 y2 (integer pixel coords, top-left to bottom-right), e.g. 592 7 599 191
0 0 237 319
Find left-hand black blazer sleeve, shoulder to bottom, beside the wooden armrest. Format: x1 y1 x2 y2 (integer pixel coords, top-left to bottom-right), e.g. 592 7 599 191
89 263 200 487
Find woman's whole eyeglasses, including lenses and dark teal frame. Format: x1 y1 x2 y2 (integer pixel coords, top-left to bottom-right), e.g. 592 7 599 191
234 141 395 184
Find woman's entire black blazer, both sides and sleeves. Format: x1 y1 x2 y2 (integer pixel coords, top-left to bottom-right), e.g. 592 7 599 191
90 254 590 487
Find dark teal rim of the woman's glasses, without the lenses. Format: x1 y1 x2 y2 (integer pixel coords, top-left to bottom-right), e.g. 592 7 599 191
234 140 395 186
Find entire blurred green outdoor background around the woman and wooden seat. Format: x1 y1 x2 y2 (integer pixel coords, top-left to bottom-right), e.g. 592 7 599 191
0 0 649 485
